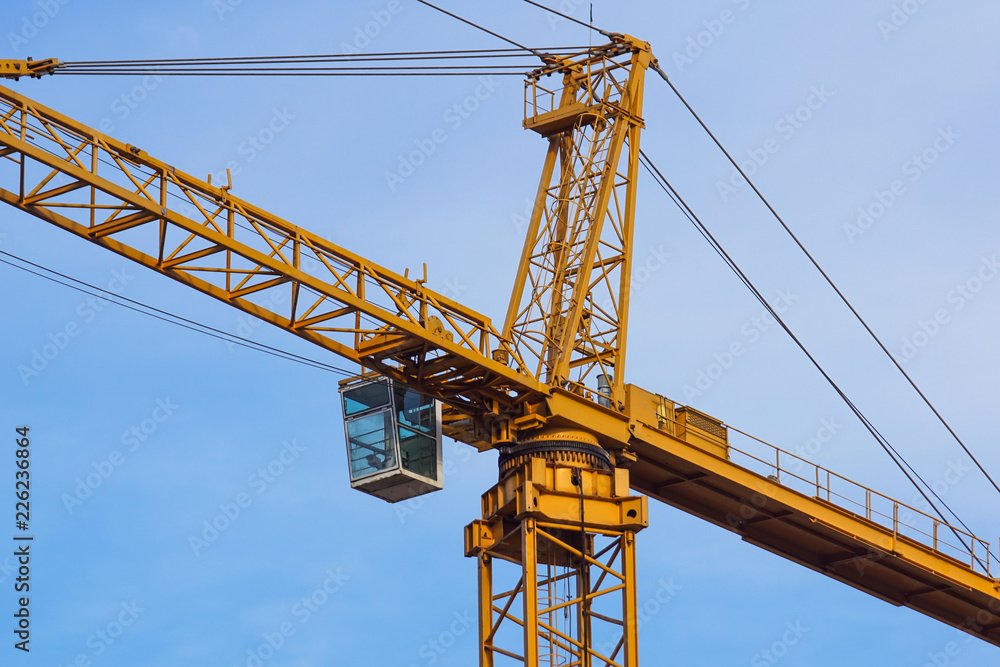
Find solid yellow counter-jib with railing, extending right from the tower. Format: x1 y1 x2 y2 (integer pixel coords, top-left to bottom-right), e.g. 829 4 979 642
524 385 1000 646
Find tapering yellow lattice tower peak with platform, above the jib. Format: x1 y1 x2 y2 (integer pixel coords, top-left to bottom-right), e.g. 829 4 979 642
503 36 650 409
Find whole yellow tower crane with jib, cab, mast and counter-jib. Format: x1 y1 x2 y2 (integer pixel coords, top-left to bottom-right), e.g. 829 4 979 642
0 35 1000 667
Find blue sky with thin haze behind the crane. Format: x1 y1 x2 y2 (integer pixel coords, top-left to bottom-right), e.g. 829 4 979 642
0 0 1000 667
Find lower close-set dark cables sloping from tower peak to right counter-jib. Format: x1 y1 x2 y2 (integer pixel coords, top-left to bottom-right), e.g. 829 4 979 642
639 151 988 571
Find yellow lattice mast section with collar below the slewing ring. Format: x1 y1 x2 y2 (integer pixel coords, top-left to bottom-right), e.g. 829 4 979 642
465 457 648 667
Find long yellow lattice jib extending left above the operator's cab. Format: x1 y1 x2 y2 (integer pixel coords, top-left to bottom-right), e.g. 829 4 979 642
0 81 546 412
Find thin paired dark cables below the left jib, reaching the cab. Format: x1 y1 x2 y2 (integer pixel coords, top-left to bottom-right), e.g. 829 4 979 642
0 250 356 377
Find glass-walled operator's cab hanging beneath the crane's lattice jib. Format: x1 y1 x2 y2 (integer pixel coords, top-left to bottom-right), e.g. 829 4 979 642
340 374 444 503
